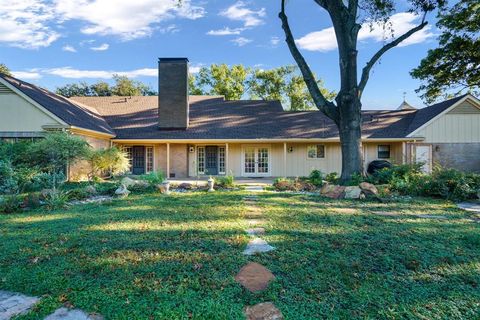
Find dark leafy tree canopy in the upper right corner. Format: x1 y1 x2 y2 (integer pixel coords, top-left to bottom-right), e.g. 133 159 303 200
411 0 480 103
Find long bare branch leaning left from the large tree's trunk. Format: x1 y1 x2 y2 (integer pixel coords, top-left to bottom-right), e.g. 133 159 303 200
278 0 339 122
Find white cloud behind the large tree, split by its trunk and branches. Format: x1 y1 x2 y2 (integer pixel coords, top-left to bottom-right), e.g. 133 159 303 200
296 12 434 52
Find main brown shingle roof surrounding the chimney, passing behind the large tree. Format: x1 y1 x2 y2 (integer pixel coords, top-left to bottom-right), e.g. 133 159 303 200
71 96 415 139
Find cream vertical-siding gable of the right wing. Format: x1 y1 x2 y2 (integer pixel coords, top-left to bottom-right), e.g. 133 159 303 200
408 96 480 143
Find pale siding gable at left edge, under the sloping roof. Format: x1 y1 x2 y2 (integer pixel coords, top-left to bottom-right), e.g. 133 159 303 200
0 79 64 135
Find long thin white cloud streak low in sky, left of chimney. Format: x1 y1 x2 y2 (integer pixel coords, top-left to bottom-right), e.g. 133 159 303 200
42 67 158 79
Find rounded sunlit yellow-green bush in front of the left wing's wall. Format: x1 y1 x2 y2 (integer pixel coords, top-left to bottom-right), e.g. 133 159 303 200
88 147 130 177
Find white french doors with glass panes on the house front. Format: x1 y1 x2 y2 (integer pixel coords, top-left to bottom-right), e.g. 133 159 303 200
242 147 270 177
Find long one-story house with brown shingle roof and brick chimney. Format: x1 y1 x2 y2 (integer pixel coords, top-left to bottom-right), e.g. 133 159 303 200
0 58 480 178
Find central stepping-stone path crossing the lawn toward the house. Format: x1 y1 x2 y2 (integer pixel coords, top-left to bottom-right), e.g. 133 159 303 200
235 194 283 320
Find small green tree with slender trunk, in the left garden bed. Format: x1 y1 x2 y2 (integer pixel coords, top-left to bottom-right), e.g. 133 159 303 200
30 132 90 189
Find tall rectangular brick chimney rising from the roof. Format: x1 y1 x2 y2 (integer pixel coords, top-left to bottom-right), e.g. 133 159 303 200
158 58 189 129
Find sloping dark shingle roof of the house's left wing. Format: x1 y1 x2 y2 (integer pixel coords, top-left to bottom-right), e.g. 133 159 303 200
0 74 114 134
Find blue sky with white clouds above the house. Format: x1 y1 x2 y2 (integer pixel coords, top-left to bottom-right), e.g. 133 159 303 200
0 0 438 109
